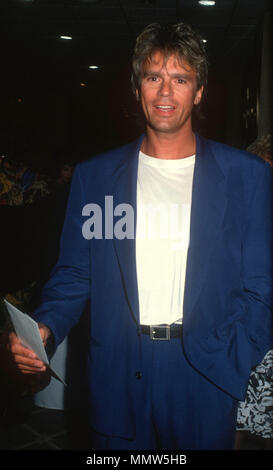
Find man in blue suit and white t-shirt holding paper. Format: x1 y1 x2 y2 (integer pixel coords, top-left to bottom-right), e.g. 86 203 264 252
7 23 272 450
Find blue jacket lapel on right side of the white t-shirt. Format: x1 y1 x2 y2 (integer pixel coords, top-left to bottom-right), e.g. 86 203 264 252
183 135 227 324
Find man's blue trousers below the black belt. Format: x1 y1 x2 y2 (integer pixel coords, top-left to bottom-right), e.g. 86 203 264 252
90 335 237 450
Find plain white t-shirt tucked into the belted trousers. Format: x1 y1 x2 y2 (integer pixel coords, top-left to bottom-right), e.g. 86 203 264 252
136 152 195 325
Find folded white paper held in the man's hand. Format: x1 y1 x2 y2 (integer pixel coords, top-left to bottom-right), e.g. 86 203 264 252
4 299 66 385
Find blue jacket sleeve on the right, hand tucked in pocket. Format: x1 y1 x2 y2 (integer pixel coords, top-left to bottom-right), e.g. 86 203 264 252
242 162 273 366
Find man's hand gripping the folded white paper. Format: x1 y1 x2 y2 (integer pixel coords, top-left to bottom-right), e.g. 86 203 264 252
8 323 51 374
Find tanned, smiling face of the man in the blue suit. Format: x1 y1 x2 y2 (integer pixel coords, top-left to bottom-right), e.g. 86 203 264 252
137 51 203 134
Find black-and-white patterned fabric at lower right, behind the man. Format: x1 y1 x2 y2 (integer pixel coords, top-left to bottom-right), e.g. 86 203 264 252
237 350 273 438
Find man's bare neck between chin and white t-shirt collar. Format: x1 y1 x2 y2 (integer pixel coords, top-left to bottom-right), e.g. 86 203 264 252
141 127 196 160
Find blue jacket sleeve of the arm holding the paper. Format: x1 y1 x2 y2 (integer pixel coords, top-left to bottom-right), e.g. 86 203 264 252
34 166 90 346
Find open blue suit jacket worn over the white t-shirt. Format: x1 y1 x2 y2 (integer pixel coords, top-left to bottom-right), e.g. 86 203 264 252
36 135 273 438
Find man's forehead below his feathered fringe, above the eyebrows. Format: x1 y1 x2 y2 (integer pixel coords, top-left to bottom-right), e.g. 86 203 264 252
142 51 196 75
